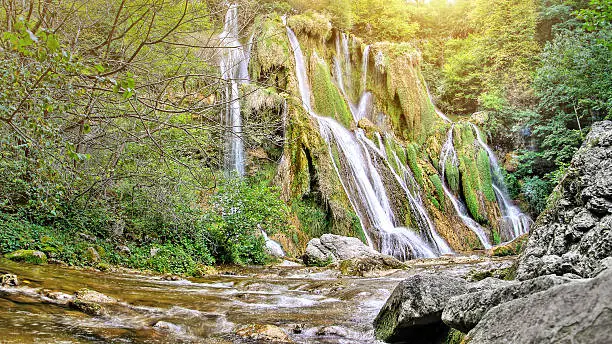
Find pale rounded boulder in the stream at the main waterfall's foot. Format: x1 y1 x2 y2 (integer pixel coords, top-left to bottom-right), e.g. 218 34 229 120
304 234 380 264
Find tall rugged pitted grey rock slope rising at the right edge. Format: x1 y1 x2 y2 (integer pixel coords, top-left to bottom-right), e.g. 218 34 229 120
517 121 612 280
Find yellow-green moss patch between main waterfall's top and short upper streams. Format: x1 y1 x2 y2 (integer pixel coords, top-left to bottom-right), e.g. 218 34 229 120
311 61 353 127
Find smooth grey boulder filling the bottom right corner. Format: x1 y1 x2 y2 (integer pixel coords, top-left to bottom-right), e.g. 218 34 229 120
466 269 612 344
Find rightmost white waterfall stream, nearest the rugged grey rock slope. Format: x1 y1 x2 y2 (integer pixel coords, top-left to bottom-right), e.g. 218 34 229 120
470 123 532 239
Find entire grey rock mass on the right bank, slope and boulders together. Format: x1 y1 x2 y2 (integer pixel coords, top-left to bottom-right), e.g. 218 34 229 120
374 121 612 344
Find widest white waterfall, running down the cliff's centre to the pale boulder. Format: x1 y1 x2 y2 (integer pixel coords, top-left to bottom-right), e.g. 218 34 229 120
287 27 437 260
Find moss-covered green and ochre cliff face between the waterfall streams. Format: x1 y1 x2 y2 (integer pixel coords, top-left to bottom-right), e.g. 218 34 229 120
246 14 501 254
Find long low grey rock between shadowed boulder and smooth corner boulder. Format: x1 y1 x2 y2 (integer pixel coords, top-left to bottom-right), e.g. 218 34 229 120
442 275 572 333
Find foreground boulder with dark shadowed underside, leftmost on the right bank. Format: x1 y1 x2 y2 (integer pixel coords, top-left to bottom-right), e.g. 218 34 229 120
374 274 467 344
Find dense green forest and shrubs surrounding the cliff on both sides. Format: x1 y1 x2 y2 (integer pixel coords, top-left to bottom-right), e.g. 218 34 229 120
0 0 612 274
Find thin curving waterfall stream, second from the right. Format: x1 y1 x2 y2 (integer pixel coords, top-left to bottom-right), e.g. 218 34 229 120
440 124 491 249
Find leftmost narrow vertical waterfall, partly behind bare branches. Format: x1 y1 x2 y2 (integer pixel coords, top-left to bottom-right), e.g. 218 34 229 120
219 4 250 176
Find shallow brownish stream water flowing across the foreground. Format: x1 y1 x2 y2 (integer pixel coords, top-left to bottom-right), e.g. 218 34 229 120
0 258 510 343
